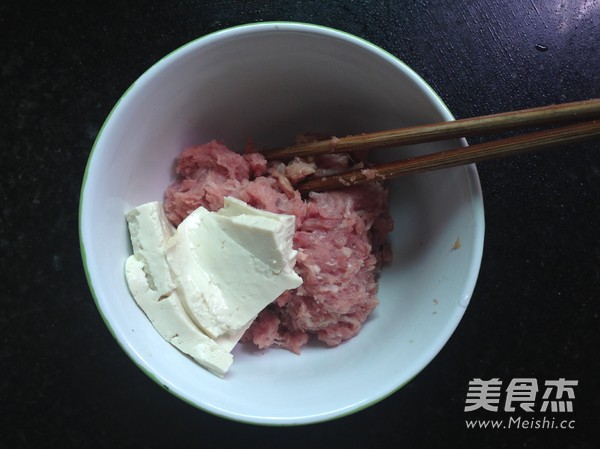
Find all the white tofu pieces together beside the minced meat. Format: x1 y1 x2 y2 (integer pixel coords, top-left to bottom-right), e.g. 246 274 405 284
125 198 302 377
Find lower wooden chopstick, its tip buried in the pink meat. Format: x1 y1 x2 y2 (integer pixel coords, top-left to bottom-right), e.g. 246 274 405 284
296 119 600 193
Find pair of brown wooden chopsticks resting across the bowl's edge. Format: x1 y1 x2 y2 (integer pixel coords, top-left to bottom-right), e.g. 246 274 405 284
263 99 600 193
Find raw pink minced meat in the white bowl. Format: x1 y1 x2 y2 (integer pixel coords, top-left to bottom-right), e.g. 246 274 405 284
165 141 392 353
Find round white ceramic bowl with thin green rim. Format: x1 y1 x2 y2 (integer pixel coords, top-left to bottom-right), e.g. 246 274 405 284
80 23 484 425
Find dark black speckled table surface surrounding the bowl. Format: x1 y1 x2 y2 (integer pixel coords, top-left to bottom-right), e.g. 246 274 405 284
0 0 600 448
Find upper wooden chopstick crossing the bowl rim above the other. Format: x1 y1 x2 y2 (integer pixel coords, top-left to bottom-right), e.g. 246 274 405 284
262 99 600 159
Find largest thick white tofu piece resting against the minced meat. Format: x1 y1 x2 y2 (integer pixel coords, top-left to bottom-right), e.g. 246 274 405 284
166 198 302 339
